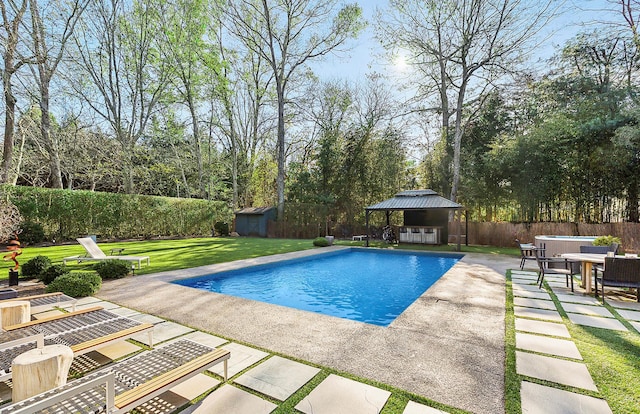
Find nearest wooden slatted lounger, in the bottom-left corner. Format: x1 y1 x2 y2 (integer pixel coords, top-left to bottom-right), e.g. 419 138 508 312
0 339 231 414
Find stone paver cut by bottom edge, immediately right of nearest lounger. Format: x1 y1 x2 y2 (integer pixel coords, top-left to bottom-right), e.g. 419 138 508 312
191 385 277 414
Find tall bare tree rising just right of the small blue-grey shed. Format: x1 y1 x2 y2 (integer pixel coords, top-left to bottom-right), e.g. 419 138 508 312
228 0 363 219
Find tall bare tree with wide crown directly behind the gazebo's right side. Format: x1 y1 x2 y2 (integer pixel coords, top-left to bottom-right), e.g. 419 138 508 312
378 0 557 201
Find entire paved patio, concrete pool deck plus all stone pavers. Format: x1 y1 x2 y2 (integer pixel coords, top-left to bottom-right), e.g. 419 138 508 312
0 247 640 414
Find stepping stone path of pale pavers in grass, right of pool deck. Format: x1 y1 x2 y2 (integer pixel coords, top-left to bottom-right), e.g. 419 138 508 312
511 270 624 414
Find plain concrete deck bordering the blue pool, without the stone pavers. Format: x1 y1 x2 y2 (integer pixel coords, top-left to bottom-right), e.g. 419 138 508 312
96 248 519 413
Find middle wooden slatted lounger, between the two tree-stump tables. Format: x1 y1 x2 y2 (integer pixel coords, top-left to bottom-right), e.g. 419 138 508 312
0 306 153 380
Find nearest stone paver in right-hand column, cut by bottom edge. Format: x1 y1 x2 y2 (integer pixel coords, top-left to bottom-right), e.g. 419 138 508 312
520 381 612 414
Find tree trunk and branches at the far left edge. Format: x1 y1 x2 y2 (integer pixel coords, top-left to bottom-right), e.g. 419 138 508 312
0 0 29 183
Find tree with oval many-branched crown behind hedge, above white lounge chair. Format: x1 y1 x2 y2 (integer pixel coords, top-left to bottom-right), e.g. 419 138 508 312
70 0 171 193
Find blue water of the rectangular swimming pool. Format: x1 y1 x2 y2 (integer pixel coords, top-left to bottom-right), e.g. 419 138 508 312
173 250 462 326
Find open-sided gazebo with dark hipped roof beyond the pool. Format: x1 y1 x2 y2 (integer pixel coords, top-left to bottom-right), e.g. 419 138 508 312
365 189 464 250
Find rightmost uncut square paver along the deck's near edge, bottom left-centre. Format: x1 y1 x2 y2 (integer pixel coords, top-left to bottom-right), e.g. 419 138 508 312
234 356 320 401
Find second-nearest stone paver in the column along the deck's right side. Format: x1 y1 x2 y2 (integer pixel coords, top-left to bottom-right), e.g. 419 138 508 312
516 351 598 391
